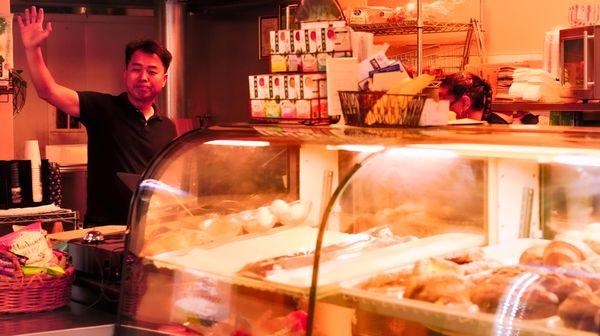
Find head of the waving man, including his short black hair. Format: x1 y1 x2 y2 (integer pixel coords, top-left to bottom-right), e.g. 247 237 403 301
123 40 172 102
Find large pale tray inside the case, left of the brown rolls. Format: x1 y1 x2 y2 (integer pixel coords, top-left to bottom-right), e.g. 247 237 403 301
148 227 485 297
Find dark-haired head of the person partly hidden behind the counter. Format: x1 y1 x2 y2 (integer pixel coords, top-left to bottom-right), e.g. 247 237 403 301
439 72 492 120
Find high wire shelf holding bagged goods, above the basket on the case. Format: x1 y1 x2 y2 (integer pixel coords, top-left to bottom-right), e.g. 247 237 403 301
350 20 472 36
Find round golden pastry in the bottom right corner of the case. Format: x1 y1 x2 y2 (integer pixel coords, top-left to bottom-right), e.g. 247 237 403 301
558 290 600 332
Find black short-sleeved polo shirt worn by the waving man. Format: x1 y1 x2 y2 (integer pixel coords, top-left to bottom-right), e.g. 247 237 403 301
77 92 176 227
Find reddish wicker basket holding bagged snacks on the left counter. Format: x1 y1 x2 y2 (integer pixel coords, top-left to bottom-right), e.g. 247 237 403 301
0 266 74 313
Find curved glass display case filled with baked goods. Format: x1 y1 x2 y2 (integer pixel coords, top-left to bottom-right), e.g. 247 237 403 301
116 126 600 335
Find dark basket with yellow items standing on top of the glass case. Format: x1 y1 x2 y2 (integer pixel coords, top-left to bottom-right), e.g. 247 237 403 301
339 91 427 127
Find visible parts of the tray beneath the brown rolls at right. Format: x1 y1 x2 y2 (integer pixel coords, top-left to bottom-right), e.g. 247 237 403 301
330 239 595 336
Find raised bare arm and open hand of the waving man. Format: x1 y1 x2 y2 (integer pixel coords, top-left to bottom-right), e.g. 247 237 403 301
17 6 80 117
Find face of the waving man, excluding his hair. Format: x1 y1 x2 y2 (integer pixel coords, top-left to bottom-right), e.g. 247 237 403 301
123 50 167 101
